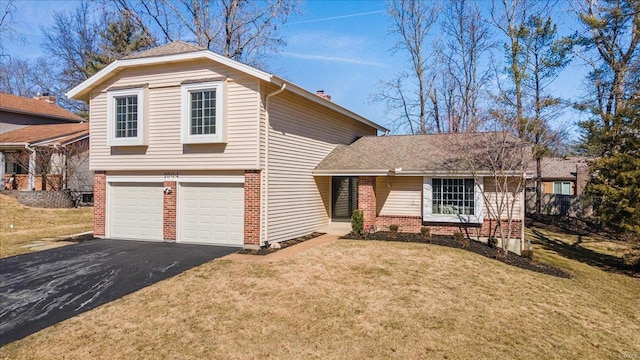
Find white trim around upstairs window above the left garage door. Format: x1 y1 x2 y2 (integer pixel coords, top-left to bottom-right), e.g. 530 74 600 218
107 88 147 146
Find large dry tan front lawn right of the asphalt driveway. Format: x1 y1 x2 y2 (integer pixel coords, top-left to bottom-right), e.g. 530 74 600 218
1 235 640 359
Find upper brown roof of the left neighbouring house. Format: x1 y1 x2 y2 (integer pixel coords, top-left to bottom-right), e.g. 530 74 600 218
0 93 84 122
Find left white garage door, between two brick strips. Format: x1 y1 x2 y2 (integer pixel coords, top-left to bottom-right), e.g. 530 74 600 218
109 183 163 240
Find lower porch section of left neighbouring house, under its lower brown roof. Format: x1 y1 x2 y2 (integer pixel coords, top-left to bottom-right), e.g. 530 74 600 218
0 123 93 194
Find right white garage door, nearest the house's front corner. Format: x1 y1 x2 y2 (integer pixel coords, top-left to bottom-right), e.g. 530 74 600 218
179 183 244 246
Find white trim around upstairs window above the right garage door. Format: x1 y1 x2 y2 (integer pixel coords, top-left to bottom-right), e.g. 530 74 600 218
180 81 226 144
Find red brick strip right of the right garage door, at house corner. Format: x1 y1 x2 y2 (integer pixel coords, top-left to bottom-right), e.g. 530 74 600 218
244 170 260 245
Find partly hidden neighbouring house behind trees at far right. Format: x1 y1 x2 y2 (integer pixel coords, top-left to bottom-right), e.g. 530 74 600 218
530 157 589 195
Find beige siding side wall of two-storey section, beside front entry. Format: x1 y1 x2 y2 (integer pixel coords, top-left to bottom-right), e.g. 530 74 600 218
267 87 376 242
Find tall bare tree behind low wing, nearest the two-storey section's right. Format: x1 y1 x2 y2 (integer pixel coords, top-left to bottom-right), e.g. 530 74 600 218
372 0 440 134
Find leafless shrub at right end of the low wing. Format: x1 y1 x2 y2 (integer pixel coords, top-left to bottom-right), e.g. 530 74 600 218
453 131 532 252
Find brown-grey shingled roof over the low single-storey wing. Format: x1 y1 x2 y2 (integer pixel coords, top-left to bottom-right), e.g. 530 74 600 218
314 133 521 173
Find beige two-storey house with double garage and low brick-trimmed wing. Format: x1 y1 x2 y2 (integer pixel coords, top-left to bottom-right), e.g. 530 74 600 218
67 42 522 253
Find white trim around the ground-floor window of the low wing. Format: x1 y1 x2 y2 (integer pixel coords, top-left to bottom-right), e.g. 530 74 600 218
422 176 484 224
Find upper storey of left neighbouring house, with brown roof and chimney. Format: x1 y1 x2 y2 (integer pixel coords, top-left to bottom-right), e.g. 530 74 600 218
0 93 84 134
